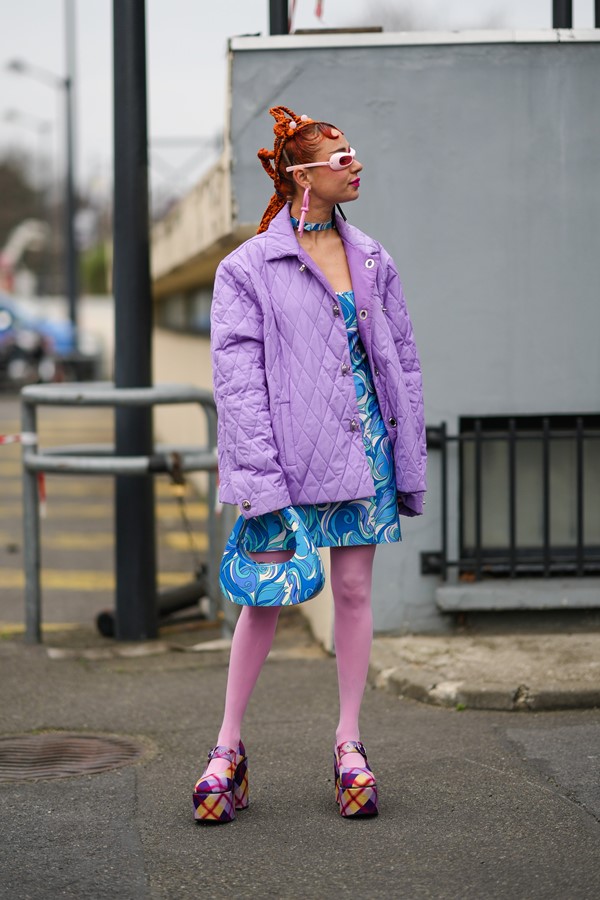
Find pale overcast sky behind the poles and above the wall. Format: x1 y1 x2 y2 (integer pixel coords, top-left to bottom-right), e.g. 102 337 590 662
0 0 594 204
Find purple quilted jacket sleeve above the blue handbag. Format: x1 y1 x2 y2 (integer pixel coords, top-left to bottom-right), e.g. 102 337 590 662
211 260 291 518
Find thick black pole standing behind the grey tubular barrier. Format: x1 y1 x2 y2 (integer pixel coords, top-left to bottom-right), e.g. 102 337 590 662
113 0 158 641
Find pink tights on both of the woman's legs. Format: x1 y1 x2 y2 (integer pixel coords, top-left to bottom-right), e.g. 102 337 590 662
207 544 375 772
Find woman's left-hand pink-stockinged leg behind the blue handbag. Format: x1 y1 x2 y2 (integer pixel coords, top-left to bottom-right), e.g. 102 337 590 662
206 550 293 774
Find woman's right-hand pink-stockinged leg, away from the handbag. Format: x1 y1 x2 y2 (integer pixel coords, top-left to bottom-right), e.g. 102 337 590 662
330 544 376 767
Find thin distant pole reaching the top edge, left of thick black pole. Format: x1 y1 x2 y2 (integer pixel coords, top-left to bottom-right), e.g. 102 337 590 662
64 0 79 334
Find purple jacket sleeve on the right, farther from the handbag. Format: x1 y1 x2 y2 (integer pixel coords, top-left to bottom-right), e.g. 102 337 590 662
384 251 427 516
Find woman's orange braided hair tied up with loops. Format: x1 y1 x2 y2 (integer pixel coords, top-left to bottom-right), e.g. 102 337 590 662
257 106 339 234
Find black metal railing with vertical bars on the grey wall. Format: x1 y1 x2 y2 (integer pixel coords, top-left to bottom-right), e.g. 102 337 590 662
421 416 600 581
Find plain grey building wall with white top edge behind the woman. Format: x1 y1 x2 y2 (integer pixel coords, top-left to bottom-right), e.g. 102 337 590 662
230 31 600 631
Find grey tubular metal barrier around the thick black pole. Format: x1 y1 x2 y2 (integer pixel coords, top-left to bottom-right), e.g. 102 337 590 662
21 382 233 643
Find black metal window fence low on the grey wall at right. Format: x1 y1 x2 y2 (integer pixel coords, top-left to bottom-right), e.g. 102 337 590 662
421 415 600 581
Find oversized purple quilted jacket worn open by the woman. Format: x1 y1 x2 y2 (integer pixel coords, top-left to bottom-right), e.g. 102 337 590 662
211 206 426 518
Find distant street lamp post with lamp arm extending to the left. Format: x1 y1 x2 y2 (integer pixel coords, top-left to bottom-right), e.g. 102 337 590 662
7 49 79 333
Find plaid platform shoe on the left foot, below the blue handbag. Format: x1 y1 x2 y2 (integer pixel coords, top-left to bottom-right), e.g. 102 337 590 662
194 741 249 823
